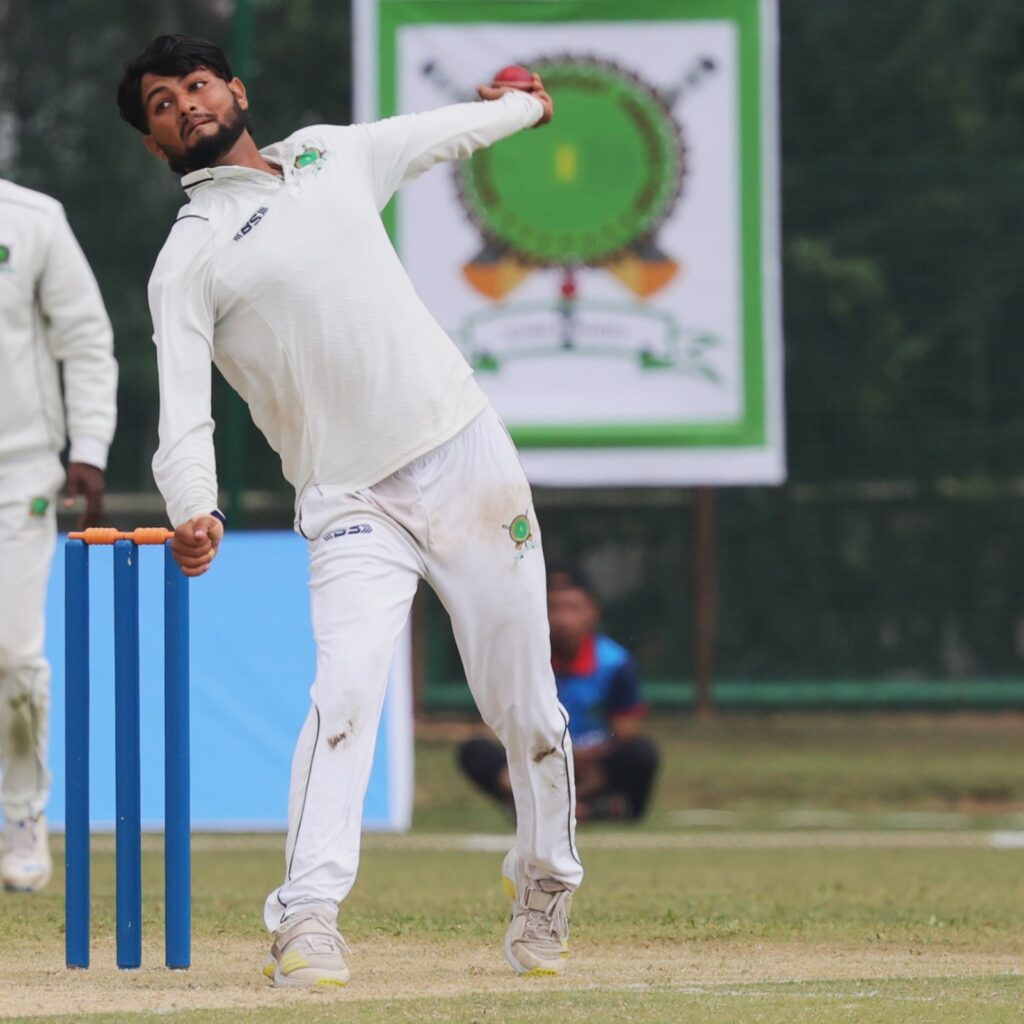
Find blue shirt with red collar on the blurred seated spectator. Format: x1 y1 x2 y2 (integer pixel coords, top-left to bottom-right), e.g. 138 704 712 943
551 634 646 749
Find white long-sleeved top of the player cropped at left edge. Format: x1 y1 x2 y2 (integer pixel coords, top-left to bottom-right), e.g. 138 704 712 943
0 180 118 469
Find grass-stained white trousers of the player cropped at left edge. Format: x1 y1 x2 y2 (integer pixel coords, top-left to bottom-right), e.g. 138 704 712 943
0 455 63 820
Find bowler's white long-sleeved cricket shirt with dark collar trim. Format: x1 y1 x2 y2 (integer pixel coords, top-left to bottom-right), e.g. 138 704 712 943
150 92 543 525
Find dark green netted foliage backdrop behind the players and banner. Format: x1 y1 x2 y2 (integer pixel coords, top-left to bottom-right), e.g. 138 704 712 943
0 0 1024 692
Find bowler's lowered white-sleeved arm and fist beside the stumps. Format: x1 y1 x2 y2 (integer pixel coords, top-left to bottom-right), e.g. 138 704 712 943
150 217 223 575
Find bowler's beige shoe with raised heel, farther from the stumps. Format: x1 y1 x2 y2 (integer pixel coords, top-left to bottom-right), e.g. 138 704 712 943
502 850 572 975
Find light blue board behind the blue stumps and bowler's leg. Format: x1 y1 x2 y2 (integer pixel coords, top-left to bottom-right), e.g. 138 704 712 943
46 532 394 829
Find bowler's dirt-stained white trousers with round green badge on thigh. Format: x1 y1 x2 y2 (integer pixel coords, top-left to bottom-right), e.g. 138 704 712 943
264 407 583 932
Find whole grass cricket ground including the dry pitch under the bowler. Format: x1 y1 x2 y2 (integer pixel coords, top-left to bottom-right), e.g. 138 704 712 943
0 717 1024 1024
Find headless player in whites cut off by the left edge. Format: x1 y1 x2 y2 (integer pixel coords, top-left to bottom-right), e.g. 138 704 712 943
0 180 118 892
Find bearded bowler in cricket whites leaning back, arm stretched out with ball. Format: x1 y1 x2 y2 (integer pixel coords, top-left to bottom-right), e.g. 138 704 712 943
118 36 583 985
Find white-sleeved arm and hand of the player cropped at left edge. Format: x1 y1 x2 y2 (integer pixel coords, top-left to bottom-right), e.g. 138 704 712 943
37 202 118 529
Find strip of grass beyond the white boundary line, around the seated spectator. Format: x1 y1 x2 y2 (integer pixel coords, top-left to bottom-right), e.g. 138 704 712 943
416 713 1024 831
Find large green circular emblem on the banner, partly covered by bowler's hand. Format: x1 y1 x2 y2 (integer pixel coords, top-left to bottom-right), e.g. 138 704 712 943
456 56 686 265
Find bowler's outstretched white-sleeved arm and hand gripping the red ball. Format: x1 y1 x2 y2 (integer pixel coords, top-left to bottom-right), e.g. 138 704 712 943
364 76 551 210
